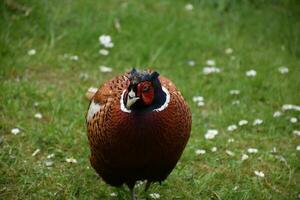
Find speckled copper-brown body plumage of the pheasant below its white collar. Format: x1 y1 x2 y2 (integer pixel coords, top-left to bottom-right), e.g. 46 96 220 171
87 73 191 186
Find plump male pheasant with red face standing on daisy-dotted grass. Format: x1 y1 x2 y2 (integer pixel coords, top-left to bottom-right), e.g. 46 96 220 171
86 69 192 200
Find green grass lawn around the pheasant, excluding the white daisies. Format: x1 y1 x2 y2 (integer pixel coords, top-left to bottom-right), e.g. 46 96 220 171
0 0 300 200
